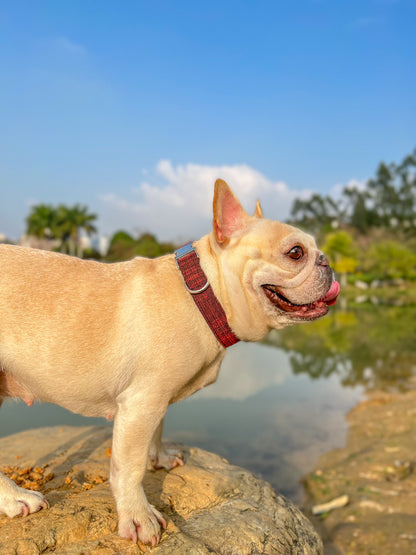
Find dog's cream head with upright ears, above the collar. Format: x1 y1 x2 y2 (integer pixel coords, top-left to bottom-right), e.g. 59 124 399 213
210 180 339 339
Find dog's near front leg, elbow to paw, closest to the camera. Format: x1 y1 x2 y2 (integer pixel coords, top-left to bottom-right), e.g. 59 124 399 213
110 392 167 545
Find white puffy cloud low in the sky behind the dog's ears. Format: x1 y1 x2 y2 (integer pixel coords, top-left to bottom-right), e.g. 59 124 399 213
100 160 311 240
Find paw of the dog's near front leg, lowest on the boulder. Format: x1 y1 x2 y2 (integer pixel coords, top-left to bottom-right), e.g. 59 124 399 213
118 504 166 546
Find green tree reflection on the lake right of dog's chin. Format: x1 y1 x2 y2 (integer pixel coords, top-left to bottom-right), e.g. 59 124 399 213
268 306 416 391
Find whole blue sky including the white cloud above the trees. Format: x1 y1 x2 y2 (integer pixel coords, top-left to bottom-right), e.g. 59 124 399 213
0 0 416 239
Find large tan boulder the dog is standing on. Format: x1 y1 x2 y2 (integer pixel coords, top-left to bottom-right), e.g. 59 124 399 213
0 427 323 555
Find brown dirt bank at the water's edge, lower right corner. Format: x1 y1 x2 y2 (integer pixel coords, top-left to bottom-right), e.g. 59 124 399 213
305 391 416 555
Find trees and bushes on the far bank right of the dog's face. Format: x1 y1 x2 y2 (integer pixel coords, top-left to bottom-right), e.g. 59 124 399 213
290 149 416 285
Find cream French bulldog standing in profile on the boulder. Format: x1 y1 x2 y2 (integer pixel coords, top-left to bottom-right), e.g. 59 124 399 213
0 180 339 545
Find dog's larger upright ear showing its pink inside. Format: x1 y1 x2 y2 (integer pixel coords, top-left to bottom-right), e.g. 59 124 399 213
213 179 249 245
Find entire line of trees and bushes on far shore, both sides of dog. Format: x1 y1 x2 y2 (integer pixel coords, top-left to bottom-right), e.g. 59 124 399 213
26 149 416 285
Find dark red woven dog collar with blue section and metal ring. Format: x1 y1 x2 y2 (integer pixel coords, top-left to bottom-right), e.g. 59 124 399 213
175 243 240 347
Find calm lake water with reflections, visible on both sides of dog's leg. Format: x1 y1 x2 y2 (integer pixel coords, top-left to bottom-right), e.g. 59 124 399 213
0 306 416 503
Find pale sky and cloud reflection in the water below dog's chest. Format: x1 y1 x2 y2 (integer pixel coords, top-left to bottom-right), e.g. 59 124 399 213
165 344 363 502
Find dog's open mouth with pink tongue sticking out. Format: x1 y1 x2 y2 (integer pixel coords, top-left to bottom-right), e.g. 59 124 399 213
262 281 340 320
